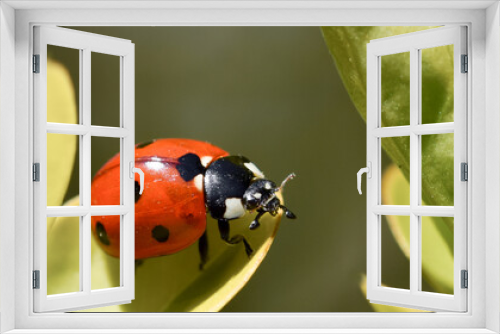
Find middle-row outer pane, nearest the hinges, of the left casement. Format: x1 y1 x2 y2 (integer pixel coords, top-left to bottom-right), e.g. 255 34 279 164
47 133 80 206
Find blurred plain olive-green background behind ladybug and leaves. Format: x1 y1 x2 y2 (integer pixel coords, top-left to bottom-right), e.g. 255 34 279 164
49 27 409 312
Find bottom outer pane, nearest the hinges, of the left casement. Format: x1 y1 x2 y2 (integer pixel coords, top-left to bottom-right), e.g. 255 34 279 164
47 217 80 295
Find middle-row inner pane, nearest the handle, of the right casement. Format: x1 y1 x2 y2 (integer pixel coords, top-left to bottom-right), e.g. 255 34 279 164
380 136 410 205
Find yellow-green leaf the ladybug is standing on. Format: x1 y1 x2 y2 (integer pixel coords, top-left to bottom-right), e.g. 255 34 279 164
48 194 281 312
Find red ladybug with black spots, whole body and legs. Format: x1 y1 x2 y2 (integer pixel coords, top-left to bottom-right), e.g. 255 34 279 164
91 139 296 269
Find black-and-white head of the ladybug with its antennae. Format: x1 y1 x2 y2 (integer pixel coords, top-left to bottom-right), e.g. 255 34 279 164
242 173 296 230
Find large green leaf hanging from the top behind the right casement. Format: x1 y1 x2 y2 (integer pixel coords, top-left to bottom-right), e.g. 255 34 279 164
322 27 453 209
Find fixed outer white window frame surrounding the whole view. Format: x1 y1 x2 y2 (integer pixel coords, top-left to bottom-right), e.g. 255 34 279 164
0 0 500 333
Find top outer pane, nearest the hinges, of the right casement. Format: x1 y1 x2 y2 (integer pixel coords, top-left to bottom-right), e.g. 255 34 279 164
421 45 454 124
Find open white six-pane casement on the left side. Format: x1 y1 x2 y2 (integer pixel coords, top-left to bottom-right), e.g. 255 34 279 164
33 25 135 312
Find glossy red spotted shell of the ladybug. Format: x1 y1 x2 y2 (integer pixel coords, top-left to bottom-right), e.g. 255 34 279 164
91 139 228 259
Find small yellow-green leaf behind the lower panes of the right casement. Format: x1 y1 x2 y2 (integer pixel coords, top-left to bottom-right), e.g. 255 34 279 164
382 165 453 294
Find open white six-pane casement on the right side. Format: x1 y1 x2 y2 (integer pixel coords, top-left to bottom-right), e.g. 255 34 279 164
366 26 468 312
